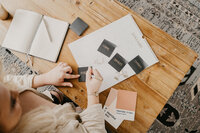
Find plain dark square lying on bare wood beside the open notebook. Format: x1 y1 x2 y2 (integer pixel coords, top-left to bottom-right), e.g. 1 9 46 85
70 17 88 36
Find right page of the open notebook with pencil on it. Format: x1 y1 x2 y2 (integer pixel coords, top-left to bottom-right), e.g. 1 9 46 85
30 16 69 62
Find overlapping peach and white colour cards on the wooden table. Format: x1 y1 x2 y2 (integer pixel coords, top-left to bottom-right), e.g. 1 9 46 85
103 88 137 129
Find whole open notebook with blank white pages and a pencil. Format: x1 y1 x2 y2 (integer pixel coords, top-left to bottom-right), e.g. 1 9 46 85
2 9 69 62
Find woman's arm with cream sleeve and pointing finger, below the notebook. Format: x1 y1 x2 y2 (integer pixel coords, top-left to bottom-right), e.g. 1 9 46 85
3 63 79 92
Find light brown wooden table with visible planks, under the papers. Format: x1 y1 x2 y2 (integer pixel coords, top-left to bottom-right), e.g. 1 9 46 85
0 0 197 133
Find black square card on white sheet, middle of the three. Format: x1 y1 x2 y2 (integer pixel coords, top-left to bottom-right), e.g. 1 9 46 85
108 53 127 72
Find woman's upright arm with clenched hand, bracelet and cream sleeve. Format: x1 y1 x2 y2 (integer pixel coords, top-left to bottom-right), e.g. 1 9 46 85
79 67 106 133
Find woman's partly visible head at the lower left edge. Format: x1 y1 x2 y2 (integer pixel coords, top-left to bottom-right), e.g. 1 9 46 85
0 61 22 132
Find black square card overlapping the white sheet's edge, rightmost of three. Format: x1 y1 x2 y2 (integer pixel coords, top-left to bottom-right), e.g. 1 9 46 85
128 55 148 74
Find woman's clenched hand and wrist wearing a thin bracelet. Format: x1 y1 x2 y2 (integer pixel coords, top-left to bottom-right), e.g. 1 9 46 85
86 67 103 107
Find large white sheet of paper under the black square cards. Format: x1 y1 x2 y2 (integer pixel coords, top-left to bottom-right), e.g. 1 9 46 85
69 14 158 92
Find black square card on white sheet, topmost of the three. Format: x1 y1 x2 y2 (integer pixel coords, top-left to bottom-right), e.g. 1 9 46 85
98 39 116 57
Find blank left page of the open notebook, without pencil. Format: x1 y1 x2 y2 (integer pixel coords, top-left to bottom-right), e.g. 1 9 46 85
2 9 42 53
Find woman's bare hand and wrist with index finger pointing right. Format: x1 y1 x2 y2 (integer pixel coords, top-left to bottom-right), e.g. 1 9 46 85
32 62 80 88
